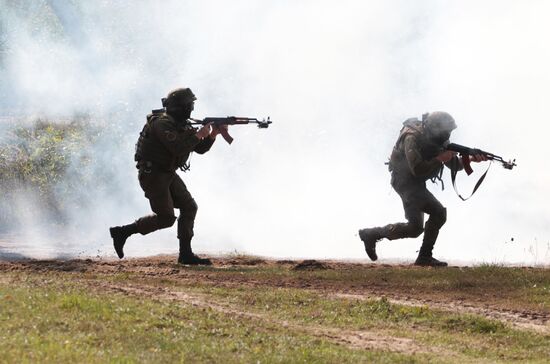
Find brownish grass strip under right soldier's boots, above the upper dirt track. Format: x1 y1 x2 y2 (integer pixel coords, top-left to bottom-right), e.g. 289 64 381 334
167 265 550 313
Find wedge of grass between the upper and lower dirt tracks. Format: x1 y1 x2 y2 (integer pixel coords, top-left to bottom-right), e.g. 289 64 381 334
163 287 550 361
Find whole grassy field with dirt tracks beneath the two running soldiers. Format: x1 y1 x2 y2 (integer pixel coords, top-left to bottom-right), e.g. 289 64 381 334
0 255 550 363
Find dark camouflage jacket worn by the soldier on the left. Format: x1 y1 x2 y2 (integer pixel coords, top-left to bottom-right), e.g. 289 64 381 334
135 113 214 171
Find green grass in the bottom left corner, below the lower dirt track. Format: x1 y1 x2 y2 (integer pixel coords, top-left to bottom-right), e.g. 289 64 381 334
0 279 418 363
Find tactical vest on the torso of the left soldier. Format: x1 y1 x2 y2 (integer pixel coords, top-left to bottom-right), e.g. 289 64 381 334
134 109 185 171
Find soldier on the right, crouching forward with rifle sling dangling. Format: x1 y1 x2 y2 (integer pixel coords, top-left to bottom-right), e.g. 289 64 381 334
359 111 486 266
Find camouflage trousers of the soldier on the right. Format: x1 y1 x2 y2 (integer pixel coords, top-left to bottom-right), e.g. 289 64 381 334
379 183 447 256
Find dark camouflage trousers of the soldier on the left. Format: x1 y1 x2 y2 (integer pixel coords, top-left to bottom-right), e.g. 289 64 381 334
136 170 198 240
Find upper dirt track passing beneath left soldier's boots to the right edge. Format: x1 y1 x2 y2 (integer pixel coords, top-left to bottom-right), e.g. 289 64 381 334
0 256 550 334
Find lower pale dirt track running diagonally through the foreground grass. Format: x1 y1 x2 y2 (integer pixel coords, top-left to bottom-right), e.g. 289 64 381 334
91 281 457 357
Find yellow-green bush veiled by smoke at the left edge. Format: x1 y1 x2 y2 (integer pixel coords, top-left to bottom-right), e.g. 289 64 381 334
0 120 111 230
